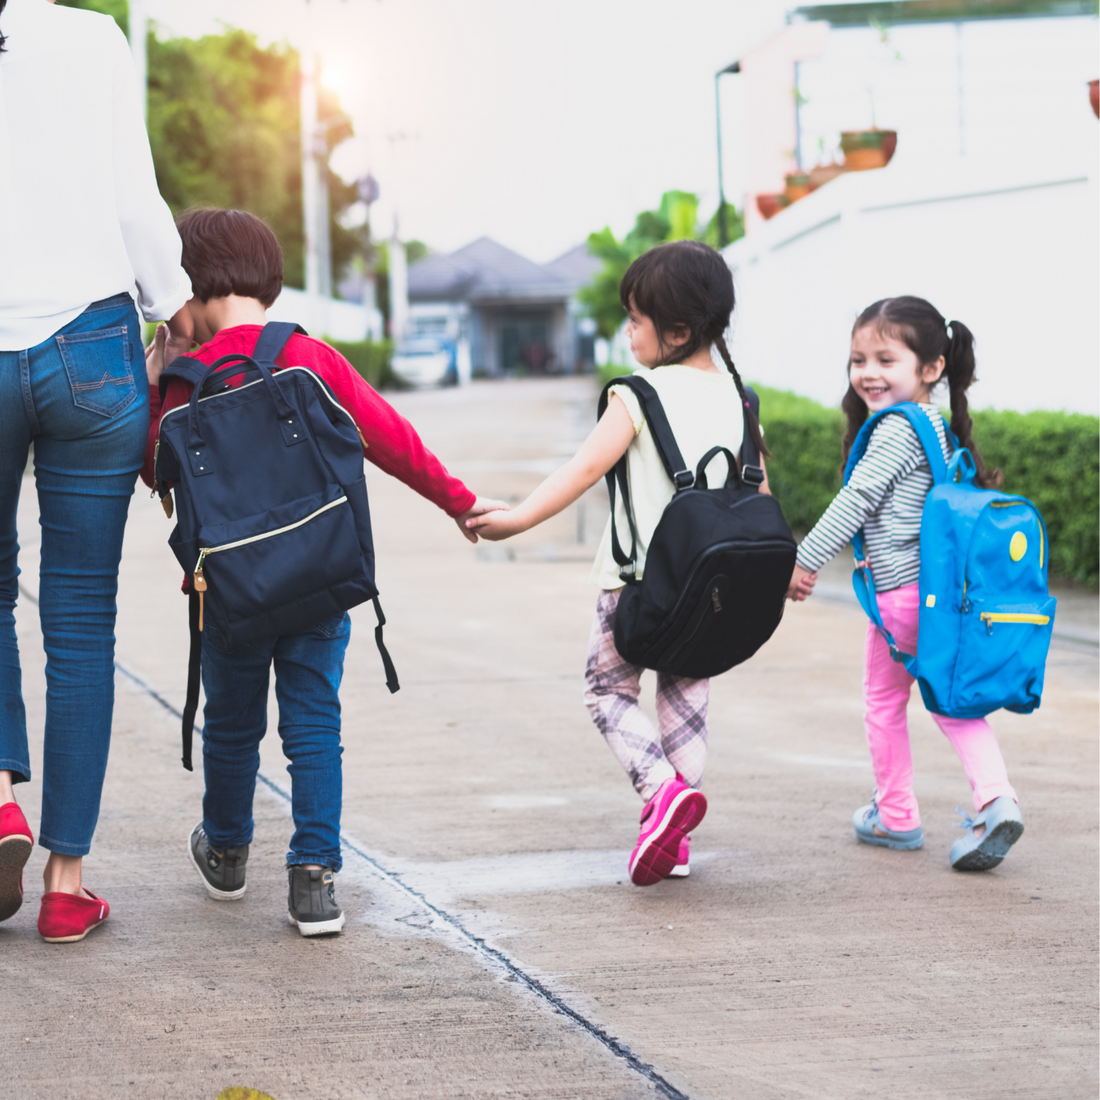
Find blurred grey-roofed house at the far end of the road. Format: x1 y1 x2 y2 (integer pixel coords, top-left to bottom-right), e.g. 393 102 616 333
406 237 600 376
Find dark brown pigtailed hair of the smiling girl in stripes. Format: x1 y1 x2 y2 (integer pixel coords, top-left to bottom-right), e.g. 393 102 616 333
840 295 1003 488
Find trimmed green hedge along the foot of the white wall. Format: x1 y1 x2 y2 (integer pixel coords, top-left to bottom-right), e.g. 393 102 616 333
598 366 1100 586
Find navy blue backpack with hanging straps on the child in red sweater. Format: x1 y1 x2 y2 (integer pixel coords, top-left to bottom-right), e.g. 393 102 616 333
154 322 399 771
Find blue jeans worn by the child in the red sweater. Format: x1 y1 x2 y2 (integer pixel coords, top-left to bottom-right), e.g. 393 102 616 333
202 614 351 871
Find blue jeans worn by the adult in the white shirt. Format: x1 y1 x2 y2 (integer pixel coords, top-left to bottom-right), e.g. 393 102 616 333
0 294 149 856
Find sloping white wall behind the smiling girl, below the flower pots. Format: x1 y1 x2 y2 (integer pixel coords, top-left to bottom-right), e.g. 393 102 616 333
725 152 1100 415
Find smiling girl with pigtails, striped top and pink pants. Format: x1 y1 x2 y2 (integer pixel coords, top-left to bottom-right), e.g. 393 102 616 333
790 297 1029 870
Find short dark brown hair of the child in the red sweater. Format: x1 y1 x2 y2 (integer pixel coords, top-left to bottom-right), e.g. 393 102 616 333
176 207 283 309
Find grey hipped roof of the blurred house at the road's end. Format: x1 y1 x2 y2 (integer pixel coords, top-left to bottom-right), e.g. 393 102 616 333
408 237 587 301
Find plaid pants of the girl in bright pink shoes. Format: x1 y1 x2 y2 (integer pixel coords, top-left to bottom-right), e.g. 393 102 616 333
584 589 711 802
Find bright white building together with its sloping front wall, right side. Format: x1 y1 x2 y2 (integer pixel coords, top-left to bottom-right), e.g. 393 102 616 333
725 0 1100 415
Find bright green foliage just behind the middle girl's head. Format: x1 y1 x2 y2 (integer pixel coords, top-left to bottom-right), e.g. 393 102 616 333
578 191 745 340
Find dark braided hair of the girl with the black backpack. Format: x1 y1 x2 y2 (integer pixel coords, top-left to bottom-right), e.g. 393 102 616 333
619 241 771 458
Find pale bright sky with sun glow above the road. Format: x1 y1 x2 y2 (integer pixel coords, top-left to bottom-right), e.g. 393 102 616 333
145 0 792 262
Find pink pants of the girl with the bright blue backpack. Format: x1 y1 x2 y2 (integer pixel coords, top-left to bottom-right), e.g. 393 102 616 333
864 584 1016 831
